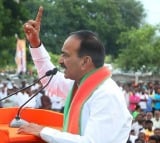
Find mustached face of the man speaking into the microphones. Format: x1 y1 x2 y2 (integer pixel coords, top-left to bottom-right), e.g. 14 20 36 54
59 36 84 81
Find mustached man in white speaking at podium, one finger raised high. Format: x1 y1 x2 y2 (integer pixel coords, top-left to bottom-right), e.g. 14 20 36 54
18 7 132 143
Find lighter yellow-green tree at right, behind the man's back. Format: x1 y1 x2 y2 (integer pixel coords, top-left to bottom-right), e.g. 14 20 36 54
116 25 160 72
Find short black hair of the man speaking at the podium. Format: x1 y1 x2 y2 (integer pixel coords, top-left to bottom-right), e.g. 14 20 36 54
70 30 105 68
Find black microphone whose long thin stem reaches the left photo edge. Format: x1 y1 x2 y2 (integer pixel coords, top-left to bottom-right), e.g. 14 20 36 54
0 68 58 102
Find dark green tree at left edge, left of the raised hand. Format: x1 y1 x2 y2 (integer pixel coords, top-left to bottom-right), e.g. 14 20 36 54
0 0 27 68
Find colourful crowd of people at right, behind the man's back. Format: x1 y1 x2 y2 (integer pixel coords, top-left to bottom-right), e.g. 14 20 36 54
120 81 160 143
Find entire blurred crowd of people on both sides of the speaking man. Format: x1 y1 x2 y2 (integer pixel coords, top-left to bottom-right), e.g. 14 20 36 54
0 75 160 143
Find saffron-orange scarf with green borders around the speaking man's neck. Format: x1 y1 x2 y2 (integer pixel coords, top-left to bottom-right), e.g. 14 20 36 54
63 67 111 134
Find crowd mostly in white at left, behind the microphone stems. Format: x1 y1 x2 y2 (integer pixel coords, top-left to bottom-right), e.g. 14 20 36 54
0 79 65 112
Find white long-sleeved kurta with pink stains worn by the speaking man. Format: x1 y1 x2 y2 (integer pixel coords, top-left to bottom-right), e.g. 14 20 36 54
31 45 132 143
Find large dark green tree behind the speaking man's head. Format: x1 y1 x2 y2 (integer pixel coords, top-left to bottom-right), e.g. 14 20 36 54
24 0 145 56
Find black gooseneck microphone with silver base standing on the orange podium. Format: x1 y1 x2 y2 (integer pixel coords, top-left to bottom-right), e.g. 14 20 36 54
9 68 58 128
